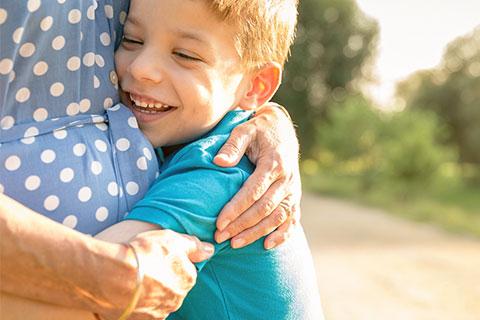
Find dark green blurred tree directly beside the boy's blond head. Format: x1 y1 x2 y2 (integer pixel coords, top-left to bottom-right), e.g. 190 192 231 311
274 0 379 155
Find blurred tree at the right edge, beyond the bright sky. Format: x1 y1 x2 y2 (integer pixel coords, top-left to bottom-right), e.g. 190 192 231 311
397 27 480 165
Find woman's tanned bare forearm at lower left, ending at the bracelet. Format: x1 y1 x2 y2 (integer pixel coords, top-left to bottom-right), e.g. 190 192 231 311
0 194 136 314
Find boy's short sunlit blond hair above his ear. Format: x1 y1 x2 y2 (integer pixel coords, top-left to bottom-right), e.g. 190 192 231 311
203 0 298 69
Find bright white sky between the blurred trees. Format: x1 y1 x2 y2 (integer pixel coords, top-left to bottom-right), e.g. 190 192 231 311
356 0 480 109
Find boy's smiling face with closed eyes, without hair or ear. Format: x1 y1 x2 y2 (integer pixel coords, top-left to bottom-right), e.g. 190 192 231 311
115 0 250 147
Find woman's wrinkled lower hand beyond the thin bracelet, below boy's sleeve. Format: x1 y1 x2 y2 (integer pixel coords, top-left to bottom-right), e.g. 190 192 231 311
113 230 214 320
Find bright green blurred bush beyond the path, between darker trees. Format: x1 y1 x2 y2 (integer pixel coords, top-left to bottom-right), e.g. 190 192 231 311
314 95 455 190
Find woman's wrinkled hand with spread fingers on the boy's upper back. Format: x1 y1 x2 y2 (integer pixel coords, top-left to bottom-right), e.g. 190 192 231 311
214 105 302 249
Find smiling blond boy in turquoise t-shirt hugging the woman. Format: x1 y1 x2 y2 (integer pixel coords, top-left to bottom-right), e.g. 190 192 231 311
98 0 323 320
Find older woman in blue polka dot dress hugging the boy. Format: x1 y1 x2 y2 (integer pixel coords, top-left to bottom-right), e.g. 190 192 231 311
0 0 300 319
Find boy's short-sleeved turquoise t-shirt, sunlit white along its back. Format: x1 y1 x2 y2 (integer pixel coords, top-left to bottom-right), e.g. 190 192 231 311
127 111 323 320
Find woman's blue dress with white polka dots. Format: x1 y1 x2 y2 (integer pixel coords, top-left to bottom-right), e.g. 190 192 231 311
0 0 158 234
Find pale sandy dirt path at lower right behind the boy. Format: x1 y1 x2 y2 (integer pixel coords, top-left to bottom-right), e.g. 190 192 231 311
302 193 480 320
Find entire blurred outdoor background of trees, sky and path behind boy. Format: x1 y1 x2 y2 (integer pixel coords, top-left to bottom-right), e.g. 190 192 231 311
274 0 480 320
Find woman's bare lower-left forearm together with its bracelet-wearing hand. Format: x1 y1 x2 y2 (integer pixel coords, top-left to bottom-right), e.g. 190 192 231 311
0 194 213 319
